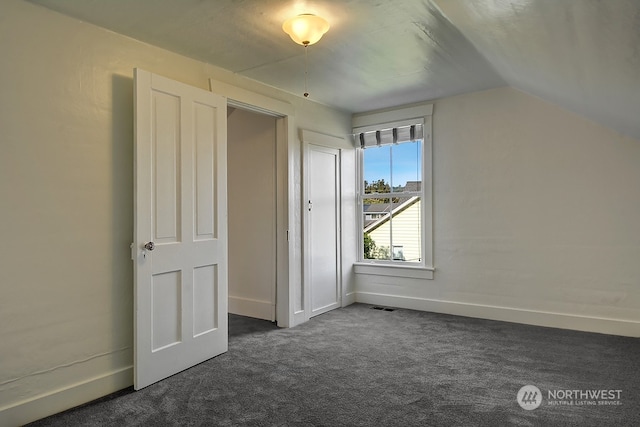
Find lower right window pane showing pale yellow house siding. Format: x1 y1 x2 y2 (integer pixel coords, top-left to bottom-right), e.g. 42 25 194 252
392 197 422 262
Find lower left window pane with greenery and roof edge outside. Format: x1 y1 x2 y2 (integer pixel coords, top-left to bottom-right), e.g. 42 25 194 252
362 198 393 259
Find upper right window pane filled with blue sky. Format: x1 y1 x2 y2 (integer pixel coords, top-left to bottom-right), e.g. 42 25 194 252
390 140 422 191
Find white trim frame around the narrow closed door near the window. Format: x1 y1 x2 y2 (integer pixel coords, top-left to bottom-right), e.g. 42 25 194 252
300 129 347 321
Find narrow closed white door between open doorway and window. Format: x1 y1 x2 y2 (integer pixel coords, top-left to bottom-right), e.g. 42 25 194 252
305 144 341 317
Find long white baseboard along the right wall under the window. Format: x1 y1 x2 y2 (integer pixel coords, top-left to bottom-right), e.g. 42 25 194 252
356 292 640 338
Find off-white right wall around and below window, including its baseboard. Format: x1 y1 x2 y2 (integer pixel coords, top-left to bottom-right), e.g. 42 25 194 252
356 88 640 336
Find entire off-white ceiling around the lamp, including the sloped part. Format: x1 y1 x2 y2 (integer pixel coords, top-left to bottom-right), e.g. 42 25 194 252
29 0 640 139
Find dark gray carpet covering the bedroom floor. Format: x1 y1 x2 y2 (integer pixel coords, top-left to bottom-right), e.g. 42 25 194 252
27 304 640 426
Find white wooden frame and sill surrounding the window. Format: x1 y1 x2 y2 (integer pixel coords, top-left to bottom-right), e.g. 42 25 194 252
352 104 434 279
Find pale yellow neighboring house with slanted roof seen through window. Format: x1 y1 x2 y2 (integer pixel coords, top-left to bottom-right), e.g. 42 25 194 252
363 181 422 262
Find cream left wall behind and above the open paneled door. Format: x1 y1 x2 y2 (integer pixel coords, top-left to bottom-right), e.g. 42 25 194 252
0 0 355 425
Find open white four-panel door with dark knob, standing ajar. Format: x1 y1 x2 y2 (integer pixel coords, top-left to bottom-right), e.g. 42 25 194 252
132 69 228 390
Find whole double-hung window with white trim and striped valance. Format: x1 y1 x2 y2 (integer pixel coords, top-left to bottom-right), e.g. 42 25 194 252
353 105 432 276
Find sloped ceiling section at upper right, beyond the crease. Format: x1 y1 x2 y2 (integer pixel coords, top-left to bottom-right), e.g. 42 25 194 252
437 0 640 139
